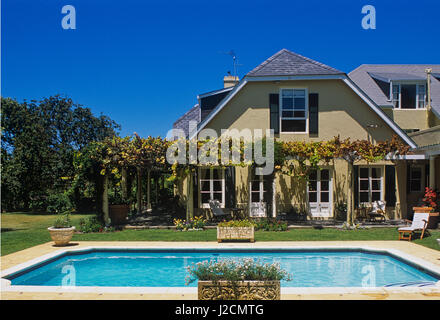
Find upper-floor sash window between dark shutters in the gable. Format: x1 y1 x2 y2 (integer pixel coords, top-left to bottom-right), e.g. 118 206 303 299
280 89 308 133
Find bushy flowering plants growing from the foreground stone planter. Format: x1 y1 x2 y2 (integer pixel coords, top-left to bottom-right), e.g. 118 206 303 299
186 258 292 285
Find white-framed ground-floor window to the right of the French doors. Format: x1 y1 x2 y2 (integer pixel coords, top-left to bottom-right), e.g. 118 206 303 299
358 167 383 203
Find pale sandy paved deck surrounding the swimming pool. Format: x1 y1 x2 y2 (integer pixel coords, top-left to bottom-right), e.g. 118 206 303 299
1 241 440 300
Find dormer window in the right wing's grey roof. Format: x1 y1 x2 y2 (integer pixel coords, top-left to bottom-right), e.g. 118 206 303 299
390 82 426 109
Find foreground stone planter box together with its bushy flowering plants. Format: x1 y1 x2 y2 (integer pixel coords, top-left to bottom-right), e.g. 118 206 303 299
186 259 292 300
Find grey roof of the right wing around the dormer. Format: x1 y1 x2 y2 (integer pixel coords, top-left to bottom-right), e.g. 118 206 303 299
348 64 440 115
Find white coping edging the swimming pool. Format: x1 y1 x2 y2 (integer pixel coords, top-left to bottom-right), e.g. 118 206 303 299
1 242 440 299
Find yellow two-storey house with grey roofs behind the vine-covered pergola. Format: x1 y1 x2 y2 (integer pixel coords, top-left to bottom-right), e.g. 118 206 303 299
174 49 440 219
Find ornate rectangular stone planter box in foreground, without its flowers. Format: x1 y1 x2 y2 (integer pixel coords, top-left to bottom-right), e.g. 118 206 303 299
197 280 281 300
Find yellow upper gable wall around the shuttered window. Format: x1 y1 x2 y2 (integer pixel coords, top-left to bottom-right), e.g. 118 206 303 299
206 80 400 141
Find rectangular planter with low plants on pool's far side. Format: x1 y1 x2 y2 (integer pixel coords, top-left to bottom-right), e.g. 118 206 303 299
217 219 255 242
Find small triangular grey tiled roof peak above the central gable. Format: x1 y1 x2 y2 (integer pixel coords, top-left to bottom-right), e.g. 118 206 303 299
247 49 344 76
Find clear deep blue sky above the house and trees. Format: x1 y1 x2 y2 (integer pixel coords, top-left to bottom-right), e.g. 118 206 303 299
1 0 440 136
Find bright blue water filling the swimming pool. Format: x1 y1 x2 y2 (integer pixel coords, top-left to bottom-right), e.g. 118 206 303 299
7 250 439 287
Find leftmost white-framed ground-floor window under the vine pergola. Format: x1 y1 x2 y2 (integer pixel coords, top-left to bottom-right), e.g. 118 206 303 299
199 168 225 208
